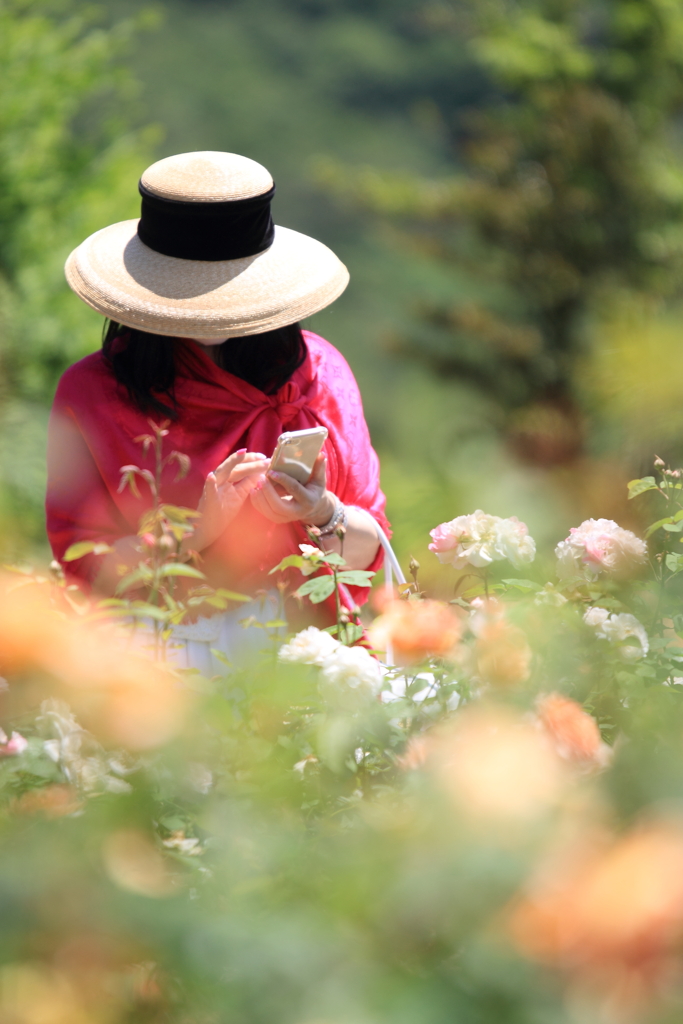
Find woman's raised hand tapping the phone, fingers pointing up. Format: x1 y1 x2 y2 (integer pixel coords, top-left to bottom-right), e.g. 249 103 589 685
188 449 270 553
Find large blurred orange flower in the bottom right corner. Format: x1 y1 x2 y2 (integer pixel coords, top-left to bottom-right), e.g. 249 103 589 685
510 820 683 1007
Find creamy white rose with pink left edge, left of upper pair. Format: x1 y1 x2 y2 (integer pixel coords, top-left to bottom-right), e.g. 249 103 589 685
429 509 536 569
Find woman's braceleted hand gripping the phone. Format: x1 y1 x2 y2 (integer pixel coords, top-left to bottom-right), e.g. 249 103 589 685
251 455 337 526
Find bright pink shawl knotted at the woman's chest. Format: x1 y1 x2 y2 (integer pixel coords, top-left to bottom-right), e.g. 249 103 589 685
47 331 388 601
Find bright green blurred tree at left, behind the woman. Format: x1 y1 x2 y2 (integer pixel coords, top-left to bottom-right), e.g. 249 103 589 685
0 0 154 553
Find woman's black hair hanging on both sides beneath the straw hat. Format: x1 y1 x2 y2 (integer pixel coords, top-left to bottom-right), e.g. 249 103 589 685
102 321 306 420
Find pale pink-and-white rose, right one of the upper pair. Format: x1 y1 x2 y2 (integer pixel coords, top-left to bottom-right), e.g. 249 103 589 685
555 519 647 580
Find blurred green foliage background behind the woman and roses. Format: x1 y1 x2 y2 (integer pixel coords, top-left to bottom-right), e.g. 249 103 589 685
0 0 683 581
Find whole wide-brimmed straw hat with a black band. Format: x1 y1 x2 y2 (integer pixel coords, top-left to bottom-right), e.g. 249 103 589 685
66 153 348 341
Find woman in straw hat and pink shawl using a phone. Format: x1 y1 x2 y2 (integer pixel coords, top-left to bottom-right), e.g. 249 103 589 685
47 153 387 667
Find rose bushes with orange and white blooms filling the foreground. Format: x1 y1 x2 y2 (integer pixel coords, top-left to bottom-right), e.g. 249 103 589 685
6 458 683 1024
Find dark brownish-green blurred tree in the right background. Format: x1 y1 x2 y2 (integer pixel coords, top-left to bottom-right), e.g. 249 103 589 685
322 0 683 464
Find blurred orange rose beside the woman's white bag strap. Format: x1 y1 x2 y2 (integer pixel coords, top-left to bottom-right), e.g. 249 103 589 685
370 601 462 665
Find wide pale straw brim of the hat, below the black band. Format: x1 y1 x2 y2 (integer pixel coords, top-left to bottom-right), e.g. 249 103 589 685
65 220 349 341
